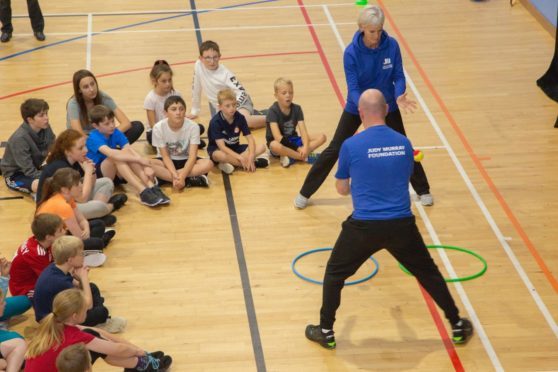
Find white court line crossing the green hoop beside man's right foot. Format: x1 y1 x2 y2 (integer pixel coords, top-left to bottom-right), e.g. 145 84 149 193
323 6 504 371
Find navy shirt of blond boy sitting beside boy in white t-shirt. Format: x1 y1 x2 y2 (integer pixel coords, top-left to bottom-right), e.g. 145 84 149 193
207 111 251 152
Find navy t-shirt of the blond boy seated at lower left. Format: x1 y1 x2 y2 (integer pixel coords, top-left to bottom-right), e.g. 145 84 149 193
33 263 74 322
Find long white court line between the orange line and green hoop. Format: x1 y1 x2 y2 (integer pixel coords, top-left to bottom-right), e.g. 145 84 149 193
322 2 558 338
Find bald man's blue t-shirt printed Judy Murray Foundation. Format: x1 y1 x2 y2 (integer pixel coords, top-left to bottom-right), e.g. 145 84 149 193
335 125 414 220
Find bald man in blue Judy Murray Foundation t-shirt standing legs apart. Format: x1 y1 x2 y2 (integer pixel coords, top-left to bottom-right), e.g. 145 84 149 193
306 89 473 349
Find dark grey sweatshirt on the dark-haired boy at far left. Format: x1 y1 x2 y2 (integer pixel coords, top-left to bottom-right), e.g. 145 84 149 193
1 122 56 178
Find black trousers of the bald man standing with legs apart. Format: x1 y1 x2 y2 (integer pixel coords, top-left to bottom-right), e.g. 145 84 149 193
320 217 459 329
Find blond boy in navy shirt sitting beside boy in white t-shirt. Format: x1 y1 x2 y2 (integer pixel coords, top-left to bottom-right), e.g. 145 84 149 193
207 89 269 174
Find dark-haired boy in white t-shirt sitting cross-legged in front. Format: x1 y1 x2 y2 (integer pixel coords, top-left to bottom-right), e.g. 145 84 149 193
152 96 213 190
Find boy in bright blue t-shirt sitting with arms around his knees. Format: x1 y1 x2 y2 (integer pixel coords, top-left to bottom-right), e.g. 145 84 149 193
86 105 170 207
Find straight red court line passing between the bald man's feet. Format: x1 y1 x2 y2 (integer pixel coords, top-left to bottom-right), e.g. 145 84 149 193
297 0 465 372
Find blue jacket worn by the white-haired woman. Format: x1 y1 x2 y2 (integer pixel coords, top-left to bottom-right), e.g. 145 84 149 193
343 30 406 115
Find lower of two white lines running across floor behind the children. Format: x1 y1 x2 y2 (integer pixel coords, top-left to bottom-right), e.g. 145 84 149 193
15 22 355 36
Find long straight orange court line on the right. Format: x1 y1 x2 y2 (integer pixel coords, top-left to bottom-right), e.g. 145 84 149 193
378 0 558 292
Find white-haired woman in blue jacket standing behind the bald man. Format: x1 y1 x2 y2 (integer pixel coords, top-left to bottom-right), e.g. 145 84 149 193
294 6 434 209
